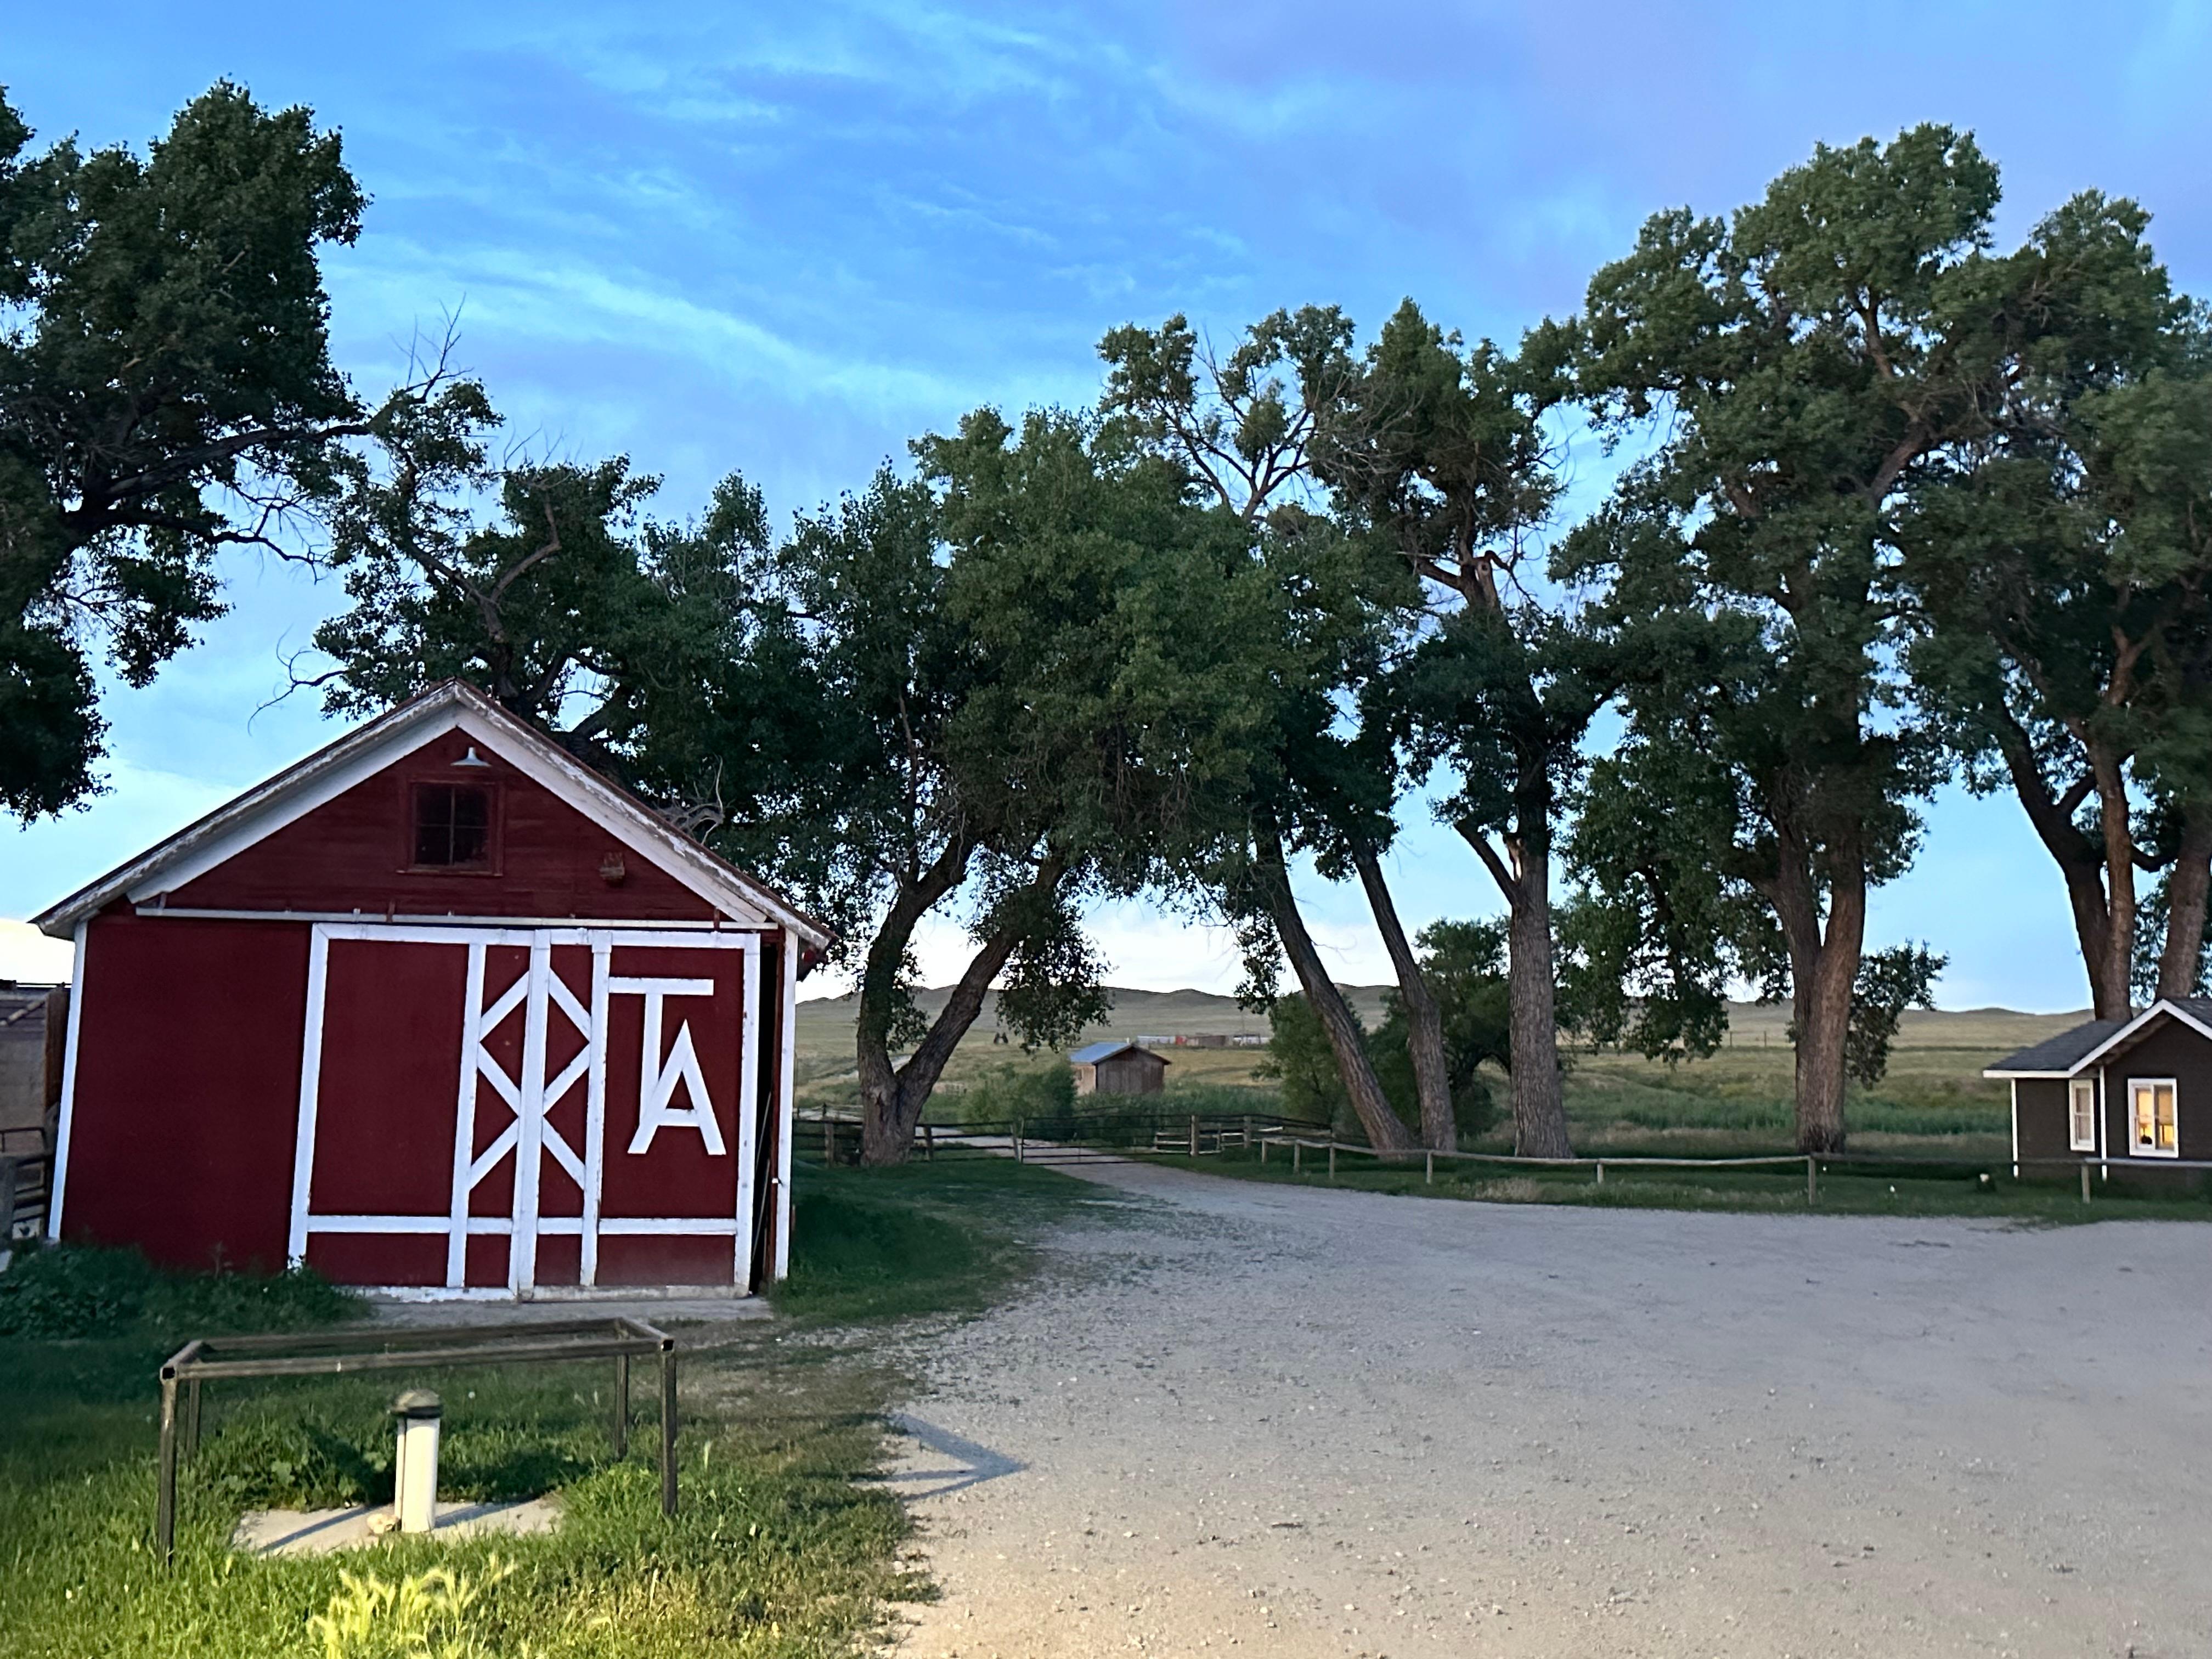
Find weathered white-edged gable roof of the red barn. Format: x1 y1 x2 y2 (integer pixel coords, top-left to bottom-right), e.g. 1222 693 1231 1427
31 679 834 951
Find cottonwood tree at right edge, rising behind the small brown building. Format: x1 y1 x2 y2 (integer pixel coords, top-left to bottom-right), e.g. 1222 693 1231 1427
1900 256 2212 1020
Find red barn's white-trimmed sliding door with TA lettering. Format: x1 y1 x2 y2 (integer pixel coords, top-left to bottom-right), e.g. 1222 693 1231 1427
292 922 759 1296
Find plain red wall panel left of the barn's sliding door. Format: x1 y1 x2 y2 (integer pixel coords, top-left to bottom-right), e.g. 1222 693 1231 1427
62 911 307 1269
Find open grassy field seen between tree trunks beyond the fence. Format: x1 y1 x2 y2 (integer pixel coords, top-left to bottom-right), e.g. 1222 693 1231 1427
799 986 2088 1157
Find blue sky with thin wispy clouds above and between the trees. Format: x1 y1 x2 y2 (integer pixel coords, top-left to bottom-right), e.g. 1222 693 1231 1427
0 0 2212 1009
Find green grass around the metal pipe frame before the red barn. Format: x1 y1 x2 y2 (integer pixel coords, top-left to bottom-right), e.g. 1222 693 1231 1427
0 1161 1088 1659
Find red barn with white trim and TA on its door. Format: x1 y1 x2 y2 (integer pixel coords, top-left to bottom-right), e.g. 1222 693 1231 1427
38 681 830 1296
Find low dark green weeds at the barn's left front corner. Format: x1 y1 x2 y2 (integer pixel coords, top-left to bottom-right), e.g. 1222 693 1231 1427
0 1245 360 1338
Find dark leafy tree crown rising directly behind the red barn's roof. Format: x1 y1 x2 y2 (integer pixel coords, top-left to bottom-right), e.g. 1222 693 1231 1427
292 381 819 836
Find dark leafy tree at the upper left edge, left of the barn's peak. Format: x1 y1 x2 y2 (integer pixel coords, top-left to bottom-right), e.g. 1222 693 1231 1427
0 82 436 819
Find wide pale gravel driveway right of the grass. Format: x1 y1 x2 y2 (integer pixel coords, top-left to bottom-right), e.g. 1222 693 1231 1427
900 1166 2212 1659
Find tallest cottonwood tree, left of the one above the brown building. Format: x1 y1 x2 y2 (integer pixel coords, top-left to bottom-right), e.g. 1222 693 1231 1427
1560 126 2040 1153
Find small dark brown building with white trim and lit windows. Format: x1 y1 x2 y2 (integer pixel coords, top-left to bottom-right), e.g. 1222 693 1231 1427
1982 997 2212 1186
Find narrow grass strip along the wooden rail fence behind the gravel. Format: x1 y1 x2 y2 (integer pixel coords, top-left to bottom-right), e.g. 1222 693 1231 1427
1150 1148 2212 1223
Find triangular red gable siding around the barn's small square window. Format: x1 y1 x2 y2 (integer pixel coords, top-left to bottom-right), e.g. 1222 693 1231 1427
168 732 714 920
